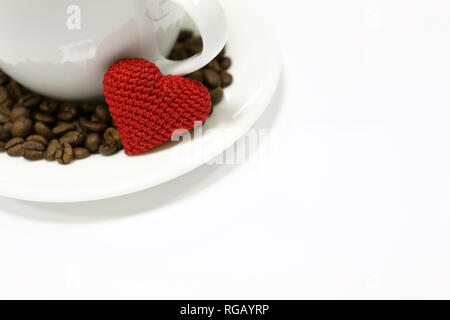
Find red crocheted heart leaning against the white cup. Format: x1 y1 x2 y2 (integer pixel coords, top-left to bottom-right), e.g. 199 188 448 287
103 59 211 155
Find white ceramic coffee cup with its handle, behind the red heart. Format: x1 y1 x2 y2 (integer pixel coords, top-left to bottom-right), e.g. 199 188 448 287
0 0 226 100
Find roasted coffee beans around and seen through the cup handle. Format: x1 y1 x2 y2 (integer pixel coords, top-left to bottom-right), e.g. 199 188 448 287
169 30 233 106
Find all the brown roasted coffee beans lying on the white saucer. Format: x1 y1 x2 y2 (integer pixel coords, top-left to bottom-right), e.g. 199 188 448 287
0 31 233 165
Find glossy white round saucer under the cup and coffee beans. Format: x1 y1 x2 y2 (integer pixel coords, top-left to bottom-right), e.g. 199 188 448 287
0 0 281 202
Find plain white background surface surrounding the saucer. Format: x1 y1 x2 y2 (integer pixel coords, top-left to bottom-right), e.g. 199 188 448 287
0 0 450 299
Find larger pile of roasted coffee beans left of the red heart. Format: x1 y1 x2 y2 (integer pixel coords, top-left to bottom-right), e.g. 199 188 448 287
0 82 122 164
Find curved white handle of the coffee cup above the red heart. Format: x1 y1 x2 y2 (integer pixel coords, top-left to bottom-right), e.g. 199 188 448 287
156 0 227 75
